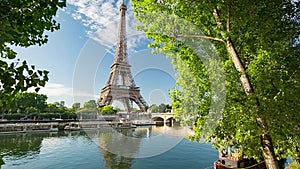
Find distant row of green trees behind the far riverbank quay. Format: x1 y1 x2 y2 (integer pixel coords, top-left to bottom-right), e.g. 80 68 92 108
0 92 172 120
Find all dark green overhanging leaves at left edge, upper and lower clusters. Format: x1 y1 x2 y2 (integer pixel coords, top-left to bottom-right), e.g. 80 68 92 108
0 0 66 109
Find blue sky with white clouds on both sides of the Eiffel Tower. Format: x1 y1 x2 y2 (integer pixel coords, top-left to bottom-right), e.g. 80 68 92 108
15 0 176 106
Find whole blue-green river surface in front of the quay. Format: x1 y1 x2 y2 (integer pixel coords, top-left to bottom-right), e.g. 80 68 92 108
0 126 218 169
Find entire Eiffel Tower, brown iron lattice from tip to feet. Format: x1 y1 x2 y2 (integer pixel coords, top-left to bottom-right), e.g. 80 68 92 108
98 1 148 112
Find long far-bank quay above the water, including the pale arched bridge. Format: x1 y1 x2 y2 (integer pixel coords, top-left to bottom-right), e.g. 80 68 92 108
0 113 174 134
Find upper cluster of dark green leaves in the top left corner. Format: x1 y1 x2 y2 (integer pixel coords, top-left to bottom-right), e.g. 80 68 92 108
0 0 66 59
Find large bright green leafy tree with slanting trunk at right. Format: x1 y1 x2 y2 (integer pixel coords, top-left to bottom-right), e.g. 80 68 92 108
132 0 300 169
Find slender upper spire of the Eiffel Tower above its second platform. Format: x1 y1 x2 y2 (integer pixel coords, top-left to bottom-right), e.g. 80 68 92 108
113 0 128 65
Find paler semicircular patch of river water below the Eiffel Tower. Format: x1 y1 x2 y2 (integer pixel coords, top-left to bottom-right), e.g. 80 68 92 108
86 126 189 158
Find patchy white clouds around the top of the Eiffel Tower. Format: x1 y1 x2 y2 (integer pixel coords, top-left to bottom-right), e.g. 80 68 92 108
68 0 146 53
